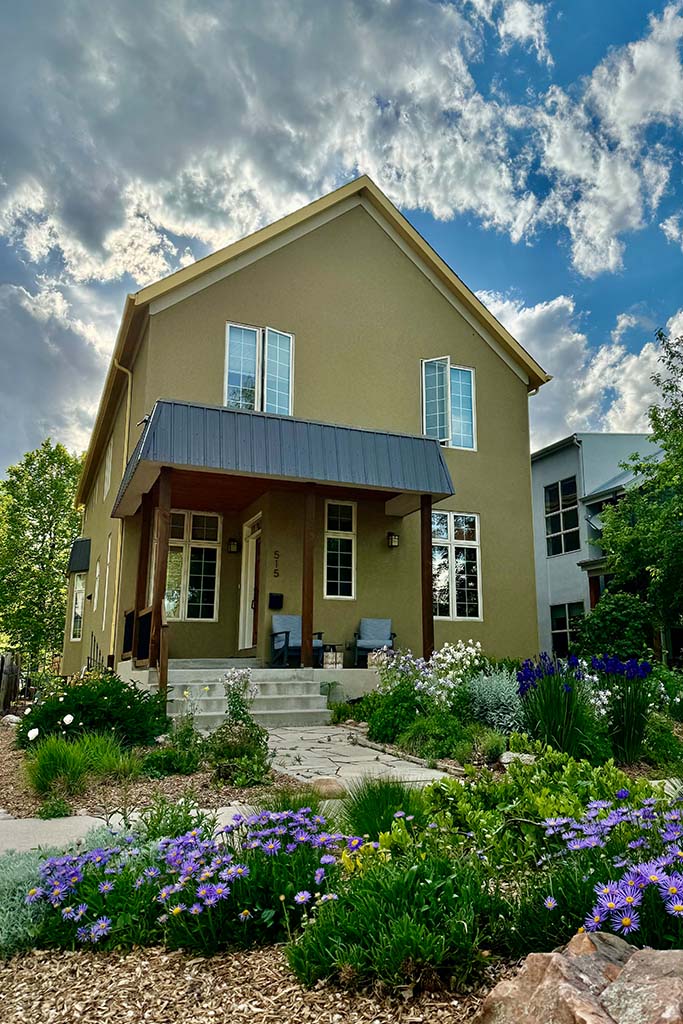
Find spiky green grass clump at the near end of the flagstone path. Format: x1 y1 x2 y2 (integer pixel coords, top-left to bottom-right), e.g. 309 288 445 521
339 778 428 840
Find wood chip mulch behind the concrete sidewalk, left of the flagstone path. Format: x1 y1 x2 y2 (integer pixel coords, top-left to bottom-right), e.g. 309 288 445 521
0 726 301 819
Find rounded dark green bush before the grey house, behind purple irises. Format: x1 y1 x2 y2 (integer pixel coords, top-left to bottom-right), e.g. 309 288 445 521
577 592 652 658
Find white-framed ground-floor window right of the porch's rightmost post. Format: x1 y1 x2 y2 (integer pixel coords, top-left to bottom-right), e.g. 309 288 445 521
432 512 482 618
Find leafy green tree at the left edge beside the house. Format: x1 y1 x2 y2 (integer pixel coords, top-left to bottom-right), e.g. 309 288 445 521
0 437 83 670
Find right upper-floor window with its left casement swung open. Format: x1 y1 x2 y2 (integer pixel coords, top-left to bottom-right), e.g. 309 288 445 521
422 355 476 451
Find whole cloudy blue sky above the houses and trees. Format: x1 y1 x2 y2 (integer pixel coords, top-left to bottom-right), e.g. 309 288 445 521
0 0 683 474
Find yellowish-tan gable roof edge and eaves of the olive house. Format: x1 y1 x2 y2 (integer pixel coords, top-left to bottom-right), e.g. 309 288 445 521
76 180 551 504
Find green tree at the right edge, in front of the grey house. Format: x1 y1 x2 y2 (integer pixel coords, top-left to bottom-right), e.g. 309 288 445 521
602 331 683 629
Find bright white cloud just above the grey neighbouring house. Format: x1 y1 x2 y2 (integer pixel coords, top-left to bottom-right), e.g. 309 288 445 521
479 293 658 449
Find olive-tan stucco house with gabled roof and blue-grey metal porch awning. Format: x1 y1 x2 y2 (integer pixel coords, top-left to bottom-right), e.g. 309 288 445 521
62 177 548 688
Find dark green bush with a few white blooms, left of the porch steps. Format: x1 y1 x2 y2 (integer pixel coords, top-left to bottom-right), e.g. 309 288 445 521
16 672 169 748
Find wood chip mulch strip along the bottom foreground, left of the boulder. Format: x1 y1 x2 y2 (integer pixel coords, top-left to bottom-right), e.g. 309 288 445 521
0 946 512 1024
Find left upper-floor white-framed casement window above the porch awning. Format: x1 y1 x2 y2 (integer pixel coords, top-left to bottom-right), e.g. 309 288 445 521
225 324 294 416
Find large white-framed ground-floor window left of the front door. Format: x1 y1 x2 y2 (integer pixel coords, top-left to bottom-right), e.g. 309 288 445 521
159 510 221 622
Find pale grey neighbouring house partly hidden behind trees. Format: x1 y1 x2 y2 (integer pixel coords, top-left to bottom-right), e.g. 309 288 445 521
531 433 659 654
